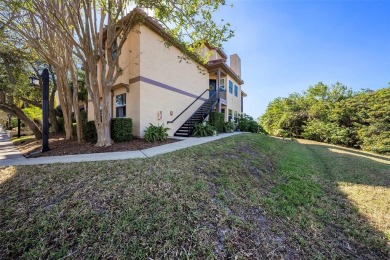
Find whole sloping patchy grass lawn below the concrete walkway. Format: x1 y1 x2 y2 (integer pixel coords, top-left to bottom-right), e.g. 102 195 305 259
0 134 390 259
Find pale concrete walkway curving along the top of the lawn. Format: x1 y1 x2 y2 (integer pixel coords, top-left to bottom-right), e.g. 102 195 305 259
0 132 241 166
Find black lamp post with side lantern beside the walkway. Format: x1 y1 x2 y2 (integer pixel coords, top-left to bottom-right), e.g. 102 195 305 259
30 69 50 153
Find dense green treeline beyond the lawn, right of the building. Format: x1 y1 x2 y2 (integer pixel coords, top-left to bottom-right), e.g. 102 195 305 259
260 82 390 154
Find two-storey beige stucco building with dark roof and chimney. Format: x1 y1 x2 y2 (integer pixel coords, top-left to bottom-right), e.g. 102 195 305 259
88 9 246 137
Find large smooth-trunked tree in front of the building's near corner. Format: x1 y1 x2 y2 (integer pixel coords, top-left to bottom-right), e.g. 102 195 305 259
8 0 233 146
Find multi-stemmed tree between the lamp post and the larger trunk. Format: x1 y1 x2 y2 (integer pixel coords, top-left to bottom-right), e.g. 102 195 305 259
0 0 81 141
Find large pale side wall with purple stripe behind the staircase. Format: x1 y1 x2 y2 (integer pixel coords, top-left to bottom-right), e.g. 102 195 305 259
140 26 209 136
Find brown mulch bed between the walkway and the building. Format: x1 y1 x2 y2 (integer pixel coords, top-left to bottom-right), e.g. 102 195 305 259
17 135 180 158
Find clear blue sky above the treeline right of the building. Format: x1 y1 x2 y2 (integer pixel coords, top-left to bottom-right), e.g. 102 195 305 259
215 0 390 118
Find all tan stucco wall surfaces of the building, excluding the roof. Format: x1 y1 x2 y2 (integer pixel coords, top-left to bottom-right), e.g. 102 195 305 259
88 25 241 137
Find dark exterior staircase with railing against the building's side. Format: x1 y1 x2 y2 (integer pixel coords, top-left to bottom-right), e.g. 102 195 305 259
174 92 218 137
